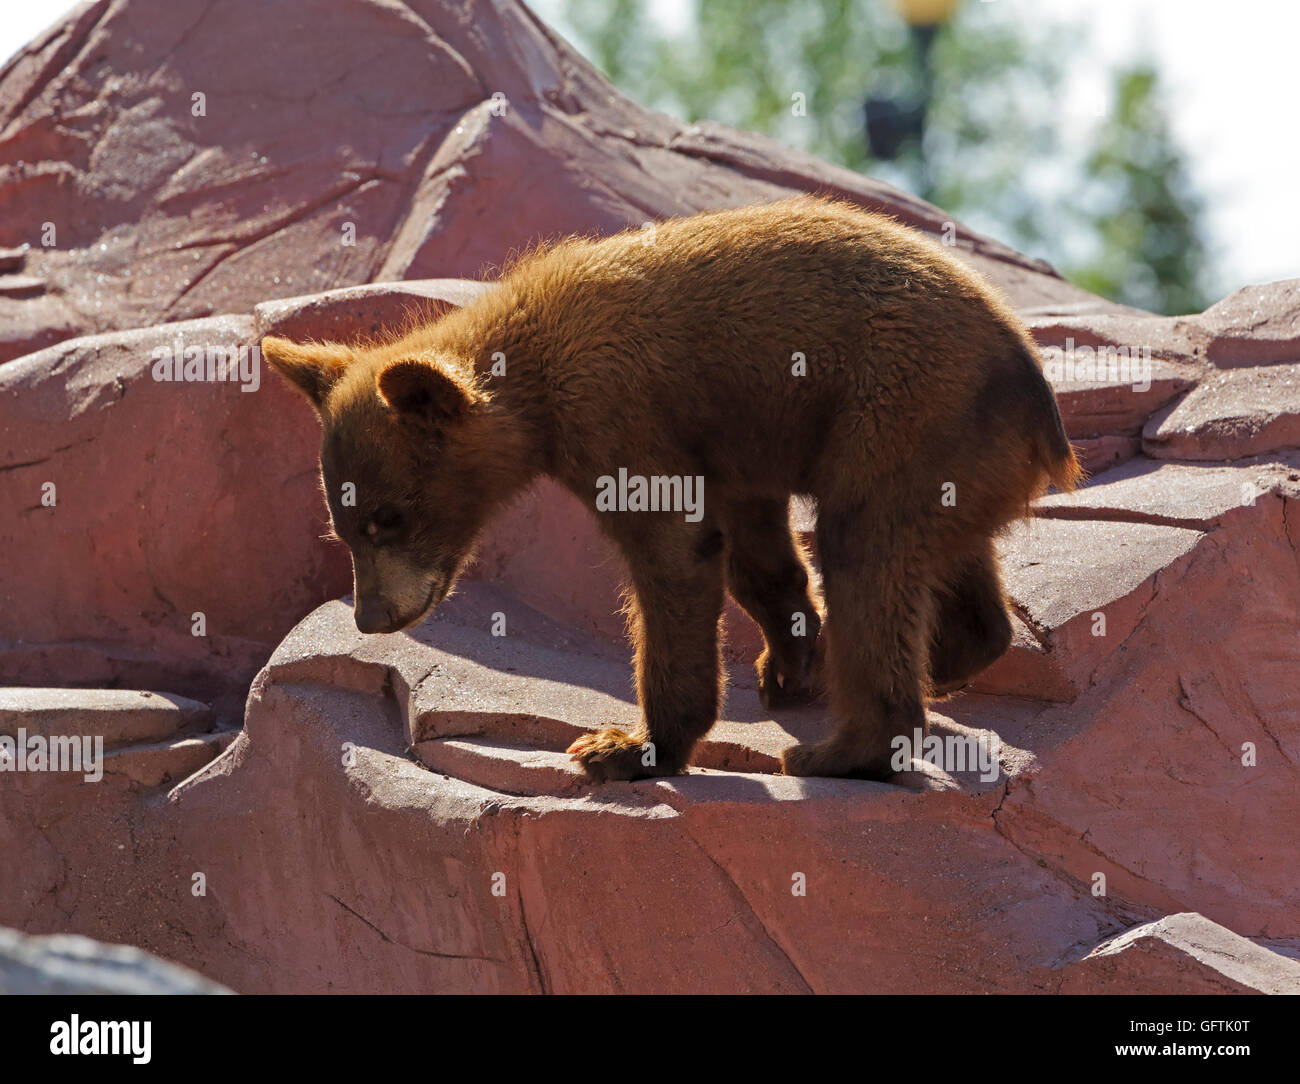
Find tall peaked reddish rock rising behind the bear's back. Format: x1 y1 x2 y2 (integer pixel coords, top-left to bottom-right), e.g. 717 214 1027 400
0 0 1097 360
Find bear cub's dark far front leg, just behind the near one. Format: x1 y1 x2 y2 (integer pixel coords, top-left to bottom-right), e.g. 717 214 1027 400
724 498 822 707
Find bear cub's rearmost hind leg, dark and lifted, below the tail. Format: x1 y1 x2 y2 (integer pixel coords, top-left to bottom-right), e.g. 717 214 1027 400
930 542 1011 697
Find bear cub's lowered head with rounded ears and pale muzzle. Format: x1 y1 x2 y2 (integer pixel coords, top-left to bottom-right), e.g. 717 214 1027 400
261 337 514 633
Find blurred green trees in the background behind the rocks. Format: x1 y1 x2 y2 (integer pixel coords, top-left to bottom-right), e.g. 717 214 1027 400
546 0 1206 313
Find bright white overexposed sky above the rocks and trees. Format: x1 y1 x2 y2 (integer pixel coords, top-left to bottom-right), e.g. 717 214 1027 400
0 0 1300 292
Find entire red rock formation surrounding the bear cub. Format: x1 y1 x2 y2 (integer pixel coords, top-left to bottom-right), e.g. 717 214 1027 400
0 0 1300 993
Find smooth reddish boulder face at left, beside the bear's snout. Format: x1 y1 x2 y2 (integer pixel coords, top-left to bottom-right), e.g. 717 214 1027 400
0 316 351 699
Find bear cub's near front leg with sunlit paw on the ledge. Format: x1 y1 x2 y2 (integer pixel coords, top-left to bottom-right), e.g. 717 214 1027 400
568 512 724 782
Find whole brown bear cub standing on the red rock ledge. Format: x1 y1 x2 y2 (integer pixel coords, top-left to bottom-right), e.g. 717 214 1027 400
263 198 1080 780
